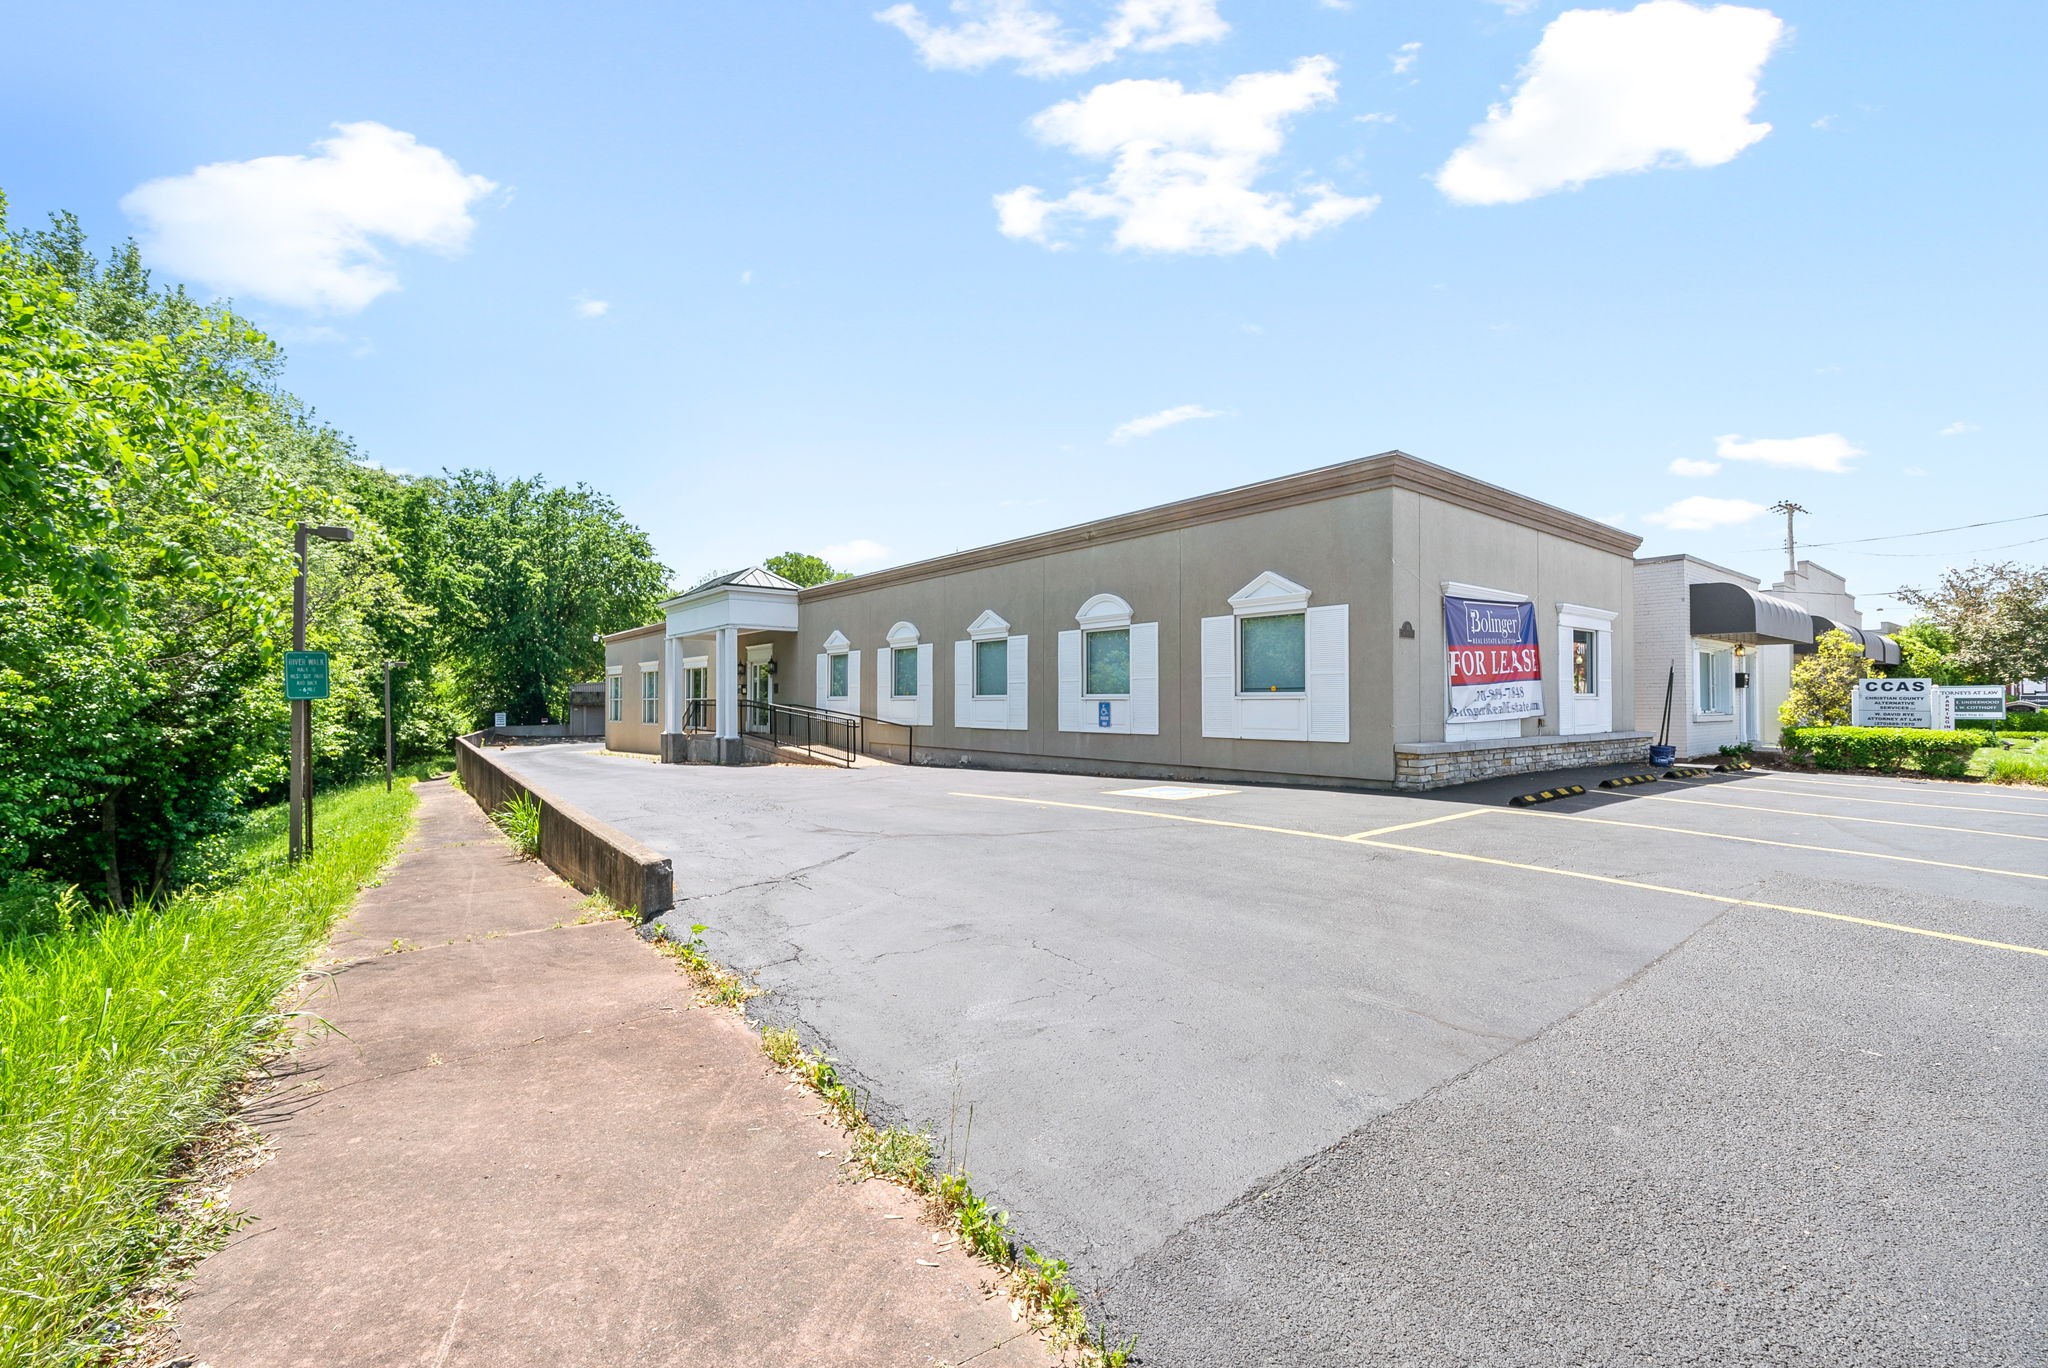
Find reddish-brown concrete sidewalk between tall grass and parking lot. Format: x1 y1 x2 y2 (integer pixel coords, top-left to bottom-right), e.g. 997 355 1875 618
178 782 1053 1368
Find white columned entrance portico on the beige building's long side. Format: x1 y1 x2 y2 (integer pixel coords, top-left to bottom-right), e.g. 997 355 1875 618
659 565 797 764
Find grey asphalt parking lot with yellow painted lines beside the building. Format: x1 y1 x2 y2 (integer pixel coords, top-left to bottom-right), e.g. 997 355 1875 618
502 747 2048 1366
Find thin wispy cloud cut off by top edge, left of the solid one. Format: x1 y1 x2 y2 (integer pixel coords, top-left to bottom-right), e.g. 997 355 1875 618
874 0 1231 76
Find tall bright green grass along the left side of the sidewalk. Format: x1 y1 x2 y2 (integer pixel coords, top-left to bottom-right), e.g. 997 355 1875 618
0 778 414 1366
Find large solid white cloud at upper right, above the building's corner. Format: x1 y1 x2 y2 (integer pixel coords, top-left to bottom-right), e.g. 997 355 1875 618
1436 0 1784 205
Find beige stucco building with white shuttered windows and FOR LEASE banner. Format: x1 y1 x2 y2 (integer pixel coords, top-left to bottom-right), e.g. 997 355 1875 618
606 453 1647 788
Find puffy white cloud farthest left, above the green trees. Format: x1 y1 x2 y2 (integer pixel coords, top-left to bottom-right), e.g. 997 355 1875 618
121 123 498 313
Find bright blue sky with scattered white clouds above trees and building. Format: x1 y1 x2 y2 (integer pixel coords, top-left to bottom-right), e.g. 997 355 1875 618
0 0 2048 614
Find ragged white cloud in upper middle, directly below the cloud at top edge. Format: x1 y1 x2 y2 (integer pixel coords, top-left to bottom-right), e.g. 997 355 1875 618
995 57 1380 254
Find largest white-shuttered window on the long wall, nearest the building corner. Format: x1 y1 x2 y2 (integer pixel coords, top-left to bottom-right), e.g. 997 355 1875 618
1202 569 1352 741
